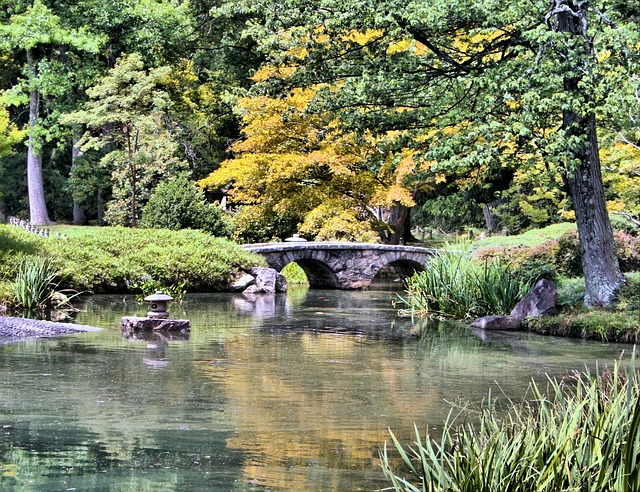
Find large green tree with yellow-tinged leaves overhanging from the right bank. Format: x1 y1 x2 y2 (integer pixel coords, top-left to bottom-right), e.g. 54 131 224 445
222 0 640 305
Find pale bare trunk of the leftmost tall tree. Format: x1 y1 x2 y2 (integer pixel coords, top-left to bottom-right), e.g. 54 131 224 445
27 50 51 225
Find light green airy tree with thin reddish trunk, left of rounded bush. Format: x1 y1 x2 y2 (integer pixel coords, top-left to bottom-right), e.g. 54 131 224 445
61 54 187 227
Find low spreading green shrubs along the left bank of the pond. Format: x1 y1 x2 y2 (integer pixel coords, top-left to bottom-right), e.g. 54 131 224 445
0 225 265 299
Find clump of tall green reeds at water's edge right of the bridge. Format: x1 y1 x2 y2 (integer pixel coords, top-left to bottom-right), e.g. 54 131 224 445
400 251 533 319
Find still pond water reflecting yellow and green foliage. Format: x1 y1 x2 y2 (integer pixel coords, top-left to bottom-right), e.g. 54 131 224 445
0 288 629 492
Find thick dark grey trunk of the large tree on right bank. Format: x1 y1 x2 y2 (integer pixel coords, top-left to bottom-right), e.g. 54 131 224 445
556 1 625 306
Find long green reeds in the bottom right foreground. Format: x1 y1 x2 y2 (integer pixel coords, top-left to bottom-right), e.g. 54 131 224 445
381 358 640 492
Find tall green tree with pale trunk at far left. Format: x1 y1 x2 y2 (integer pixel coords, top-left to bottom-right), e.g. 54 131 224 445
0 0 101 224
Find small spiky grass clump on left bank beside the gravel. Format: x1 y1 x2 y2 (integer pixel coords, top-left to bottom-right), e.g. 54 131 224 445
12 256 59 309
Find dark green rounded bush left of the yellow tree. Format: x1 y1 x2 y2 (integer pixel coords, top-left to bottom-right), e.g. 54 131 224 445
140 176 231 237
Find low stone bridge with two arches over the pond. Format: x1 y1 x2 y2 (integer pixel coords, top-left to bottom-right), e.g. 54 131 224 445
243 242 435 289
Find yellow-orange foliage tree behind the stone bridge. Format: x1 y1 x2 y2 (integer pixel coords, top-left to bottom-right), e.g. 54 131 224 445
198 85 413 242
